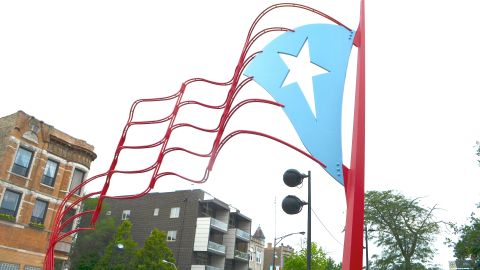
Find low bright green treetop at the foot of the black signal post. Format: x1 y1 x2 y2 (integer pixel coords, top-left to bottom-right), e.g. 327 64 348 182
282 243 342 270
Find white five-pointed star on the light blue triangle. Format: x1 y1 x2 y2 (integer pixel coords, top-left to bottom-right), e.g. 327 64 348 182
279 39 328 118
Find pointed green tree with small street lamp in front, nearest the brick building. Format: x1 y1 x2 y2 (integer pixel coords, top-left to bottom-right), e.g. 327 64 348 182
94 220 137 270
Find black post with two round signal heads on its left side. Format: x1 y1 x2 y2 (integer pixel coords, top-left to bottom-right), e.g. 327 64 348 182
282 169 312 270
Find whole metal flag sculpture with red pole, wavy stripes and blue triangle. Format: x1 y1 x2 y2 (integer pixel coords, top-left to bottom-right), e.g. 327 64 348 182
44 1 365 270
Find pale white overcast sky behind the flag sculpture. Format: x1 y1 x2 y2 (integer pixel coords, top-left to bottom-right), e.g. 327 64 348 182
0 0 480 269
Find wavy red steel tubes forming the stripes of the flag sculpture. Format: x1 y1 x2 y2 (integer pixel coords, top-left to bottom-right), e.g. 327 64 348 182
44 3 356 270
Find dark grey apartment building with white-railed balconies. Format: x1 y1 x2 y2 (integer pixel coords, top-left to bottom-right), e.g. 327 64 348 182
105 189 251 270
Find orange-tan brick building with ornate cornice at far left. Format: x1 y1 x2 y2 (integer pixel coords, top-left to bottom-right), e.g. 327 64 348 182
0 111 96 270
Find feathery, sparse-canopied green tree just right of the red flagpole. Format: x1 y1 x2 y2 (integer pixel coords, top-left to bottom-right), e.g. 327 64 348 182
365 190 440 270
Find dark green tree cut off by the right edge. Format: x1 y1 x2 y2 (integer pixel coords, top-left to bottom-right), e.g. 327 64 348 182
453 204 480 269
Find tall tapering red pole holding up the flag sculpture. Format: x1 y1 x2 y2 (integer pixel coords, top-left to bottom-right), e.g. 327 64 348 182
342 0 365 270
